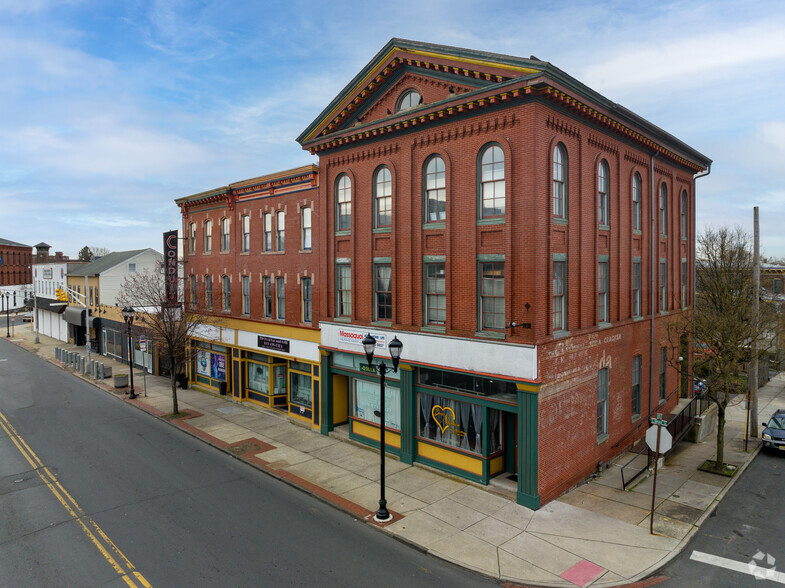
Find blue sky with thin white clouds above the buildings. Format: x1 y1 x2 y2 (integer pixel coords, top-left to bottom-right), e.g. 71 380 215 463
0 0 785 259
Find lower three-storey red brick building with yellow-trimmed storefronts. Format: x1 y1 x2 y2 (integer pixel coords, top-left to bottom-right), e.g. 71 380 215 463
176 165 320 426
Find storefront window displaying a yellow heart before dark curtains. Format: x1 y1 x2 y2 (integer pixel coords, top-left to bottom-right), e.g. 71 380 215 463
418 394 502 455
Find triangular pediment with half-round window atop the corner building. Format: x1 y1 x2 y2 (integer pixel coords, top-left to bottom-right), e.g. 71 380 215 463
297 39 548 147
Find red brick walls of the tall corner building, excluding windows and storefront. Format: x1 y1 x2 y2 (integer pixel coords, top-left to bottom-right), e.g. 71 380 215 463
298 39 711 501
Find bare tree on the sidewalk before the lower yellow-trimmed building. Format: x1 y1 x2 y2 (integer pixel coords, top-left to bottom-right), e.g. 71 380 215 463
118 271 210 414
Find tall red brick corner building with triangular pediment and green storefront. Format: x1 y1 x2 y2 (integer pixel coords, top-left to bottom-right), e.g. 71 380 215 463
296 39 711 508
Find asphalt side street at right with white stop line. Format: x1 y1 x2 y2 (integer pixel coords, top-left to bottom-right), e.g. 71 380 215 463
657 448 785 588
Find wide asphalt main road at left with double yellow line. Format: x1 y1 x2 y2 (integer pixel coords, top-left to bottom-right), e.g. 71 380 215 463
0 338 496 587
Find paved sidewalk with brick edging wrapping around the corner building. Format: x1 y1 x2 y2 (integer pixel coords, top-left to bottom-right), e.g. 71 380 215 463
11 325 785 586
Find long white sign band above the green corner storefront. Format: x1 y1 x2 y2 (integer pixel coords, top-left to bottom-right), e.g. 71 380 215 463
319 322 537 380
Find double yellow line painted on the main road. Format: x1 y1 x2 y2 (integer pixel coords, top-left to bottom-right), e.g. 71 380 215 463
0 412 151 588
